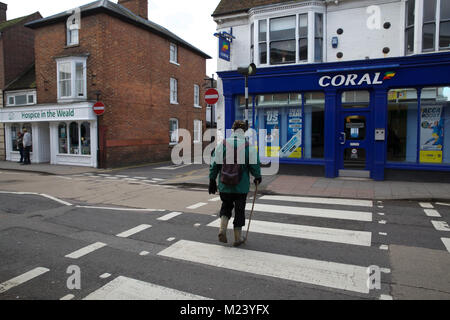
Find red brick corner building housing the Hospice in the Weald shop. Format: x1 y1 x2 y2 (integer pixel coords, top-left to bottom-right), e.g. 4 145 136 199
0 0 210 167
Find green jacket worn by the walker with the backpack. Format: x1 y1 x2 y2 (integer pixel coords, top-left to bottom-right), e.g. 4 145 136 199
209 133 261 194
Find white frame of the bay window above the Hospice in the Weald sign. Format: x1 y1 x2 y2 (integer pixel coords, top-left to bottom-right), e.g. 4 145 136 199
56 57 87 102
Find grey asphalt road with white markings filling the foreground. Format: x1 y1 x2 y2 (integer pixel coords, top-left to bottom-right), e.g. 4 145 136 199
0 191 450 300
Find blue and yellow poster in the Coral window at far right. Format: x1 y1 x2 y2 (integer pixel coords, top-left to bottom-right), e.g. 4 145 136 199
420 106 444 163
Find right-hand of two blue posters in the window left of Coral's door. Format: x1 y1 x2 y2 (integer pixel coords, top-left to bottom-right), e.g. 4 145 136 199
280 108 303 159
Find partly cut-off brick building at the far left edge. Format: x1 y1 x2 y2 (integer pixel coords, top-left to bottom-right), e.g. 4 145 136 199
0 2 42 160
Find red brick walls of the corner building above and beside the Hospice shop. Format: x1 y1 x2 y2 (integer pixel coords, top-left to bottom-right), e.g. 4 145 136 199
35 14 206 167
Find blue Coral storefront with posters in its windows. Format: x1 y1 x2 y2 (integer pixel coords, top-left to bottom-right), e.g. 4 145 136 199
219 52 450 180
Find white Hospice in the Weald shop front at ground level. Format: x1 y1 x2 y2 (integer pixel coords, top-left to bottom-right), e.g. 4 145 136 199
0 102 98 168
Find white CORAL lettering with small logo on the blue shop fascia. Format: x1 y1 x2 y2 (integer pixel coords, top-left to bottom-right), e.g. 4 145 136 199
319 71 396 88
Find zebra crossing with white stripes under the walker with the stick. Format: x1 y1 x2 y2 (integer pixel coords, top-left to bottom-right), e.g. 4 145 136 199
0 196 390 300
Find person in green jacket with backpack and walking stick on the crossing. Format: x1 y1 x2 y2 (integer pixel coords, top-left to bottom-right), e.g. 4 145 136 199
209 121 262 247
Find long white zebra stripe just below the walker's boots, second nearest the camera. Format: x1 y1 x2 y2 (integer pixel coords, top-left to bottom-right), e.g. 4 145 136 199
158 240 369 293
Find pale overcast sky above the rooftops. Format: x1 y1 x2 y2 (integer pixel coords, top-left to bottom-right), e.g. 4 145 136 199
0 0 220 78
